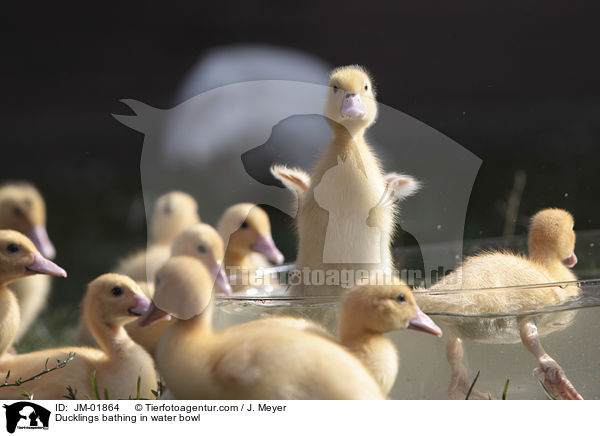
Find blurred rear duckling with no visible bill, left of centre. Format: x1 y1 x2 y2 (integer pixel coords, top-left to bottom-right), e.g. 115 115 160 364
116 191 200 283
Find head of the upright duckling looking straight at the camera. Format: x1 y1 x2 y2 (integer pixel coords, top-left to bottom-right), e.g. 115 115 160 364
325 65 377 136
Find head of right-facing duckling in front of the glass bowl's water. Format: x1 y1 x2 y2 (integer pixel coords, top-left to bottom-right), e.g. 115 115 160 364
340 281 442 336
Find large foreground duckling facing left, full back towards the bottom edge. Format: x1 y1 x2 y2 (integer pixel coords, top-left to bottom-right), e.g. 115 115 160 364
143 256 384 400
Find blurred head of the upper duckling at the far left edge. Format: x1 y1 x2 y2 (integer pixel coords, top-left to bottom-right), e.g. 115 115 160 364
0 183 56 259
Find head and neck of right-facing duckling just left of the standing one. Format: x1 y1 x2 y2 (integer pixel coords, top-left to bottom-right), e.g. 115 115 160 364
217 203 284 290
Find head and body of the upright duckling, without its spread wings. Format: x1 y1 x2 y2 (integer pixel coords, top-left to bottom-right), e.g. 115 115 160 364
291 66 395 295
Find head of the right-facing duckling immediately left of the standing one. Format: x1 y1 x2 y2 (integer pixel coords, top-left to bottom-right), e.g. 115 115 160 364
217 203 284 265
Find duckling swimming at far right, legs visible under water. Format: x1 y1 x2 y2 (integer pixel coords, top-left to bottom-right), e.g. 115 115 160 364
416 209 581 399
